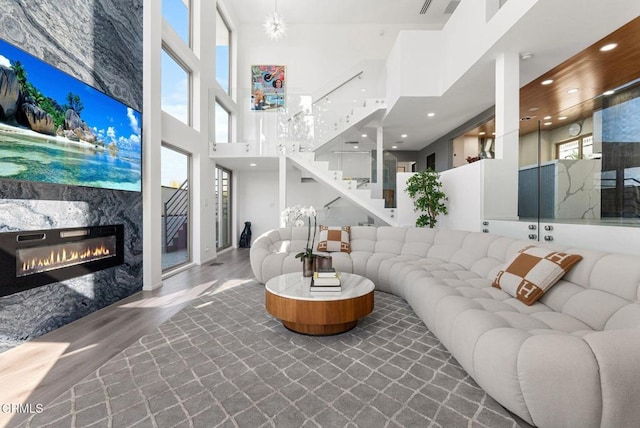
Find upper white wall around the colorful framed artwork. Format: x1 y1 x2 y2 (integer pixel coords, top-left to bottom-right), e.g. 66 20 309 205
236 24 418 147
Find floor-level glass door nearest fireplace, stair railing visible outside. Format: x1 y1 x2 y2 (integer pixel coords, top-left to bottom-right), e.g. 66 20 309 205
160 146 191 271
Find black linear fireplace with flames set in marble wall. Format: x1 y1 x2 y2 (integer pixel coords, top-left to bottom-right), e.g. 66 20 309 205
0 224 124 296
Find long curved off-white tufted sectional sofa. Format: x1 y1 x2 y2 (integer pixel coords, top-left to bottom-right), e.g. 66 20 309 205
251 227 640 428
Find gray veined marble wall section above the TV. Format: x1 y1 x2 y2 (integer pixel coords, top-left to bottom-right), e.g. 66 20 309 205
0 0 143 111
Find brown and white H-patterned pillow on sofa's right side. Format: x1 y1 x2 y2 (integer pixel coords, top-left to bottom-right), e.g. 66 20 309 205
493 247 582 306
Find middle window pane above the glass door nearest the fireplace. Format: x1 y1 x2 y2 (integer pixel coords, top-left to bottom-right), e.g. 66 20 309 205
161 49 191 125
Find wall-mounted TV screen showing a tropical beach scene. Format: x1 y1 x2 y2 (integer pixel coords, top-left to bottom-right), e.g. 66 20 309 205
0 39 142 191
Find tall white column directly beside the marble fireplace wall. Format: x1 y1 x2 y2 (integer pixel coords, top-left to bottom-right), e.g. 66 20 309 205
142 0 162 290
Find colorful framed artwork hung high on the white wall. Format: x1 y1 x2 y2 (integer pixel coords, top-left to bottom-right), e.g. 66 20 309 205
251 65 286 111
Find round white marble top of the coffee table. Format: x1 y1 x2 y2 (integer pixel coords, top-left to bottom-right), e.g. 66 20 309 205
265 272 375 301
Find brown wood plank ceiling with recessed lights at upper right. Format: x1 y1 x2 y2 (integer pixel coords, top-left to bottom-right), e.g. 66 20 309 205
520 17 640 135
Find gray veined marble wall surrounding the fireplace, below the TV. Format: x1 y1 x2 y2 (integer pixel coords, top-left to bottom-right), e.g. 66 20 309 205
0 180 142 352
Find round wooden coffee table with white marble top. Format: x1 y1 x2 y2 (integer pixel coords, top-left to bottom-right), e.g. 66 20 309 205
265 272 374 335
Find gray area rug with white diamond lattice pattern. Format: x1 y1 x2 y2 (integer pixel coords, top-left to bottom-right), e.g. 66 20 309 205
17 281 518 428
